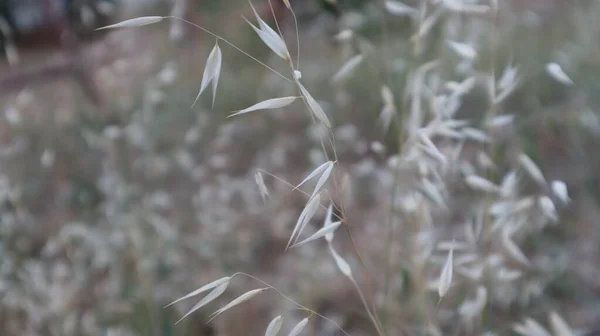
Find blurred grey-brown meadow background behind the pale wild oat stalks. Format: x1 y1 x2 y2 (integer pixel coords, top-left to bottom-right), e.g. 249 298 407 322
0 0 600 336
